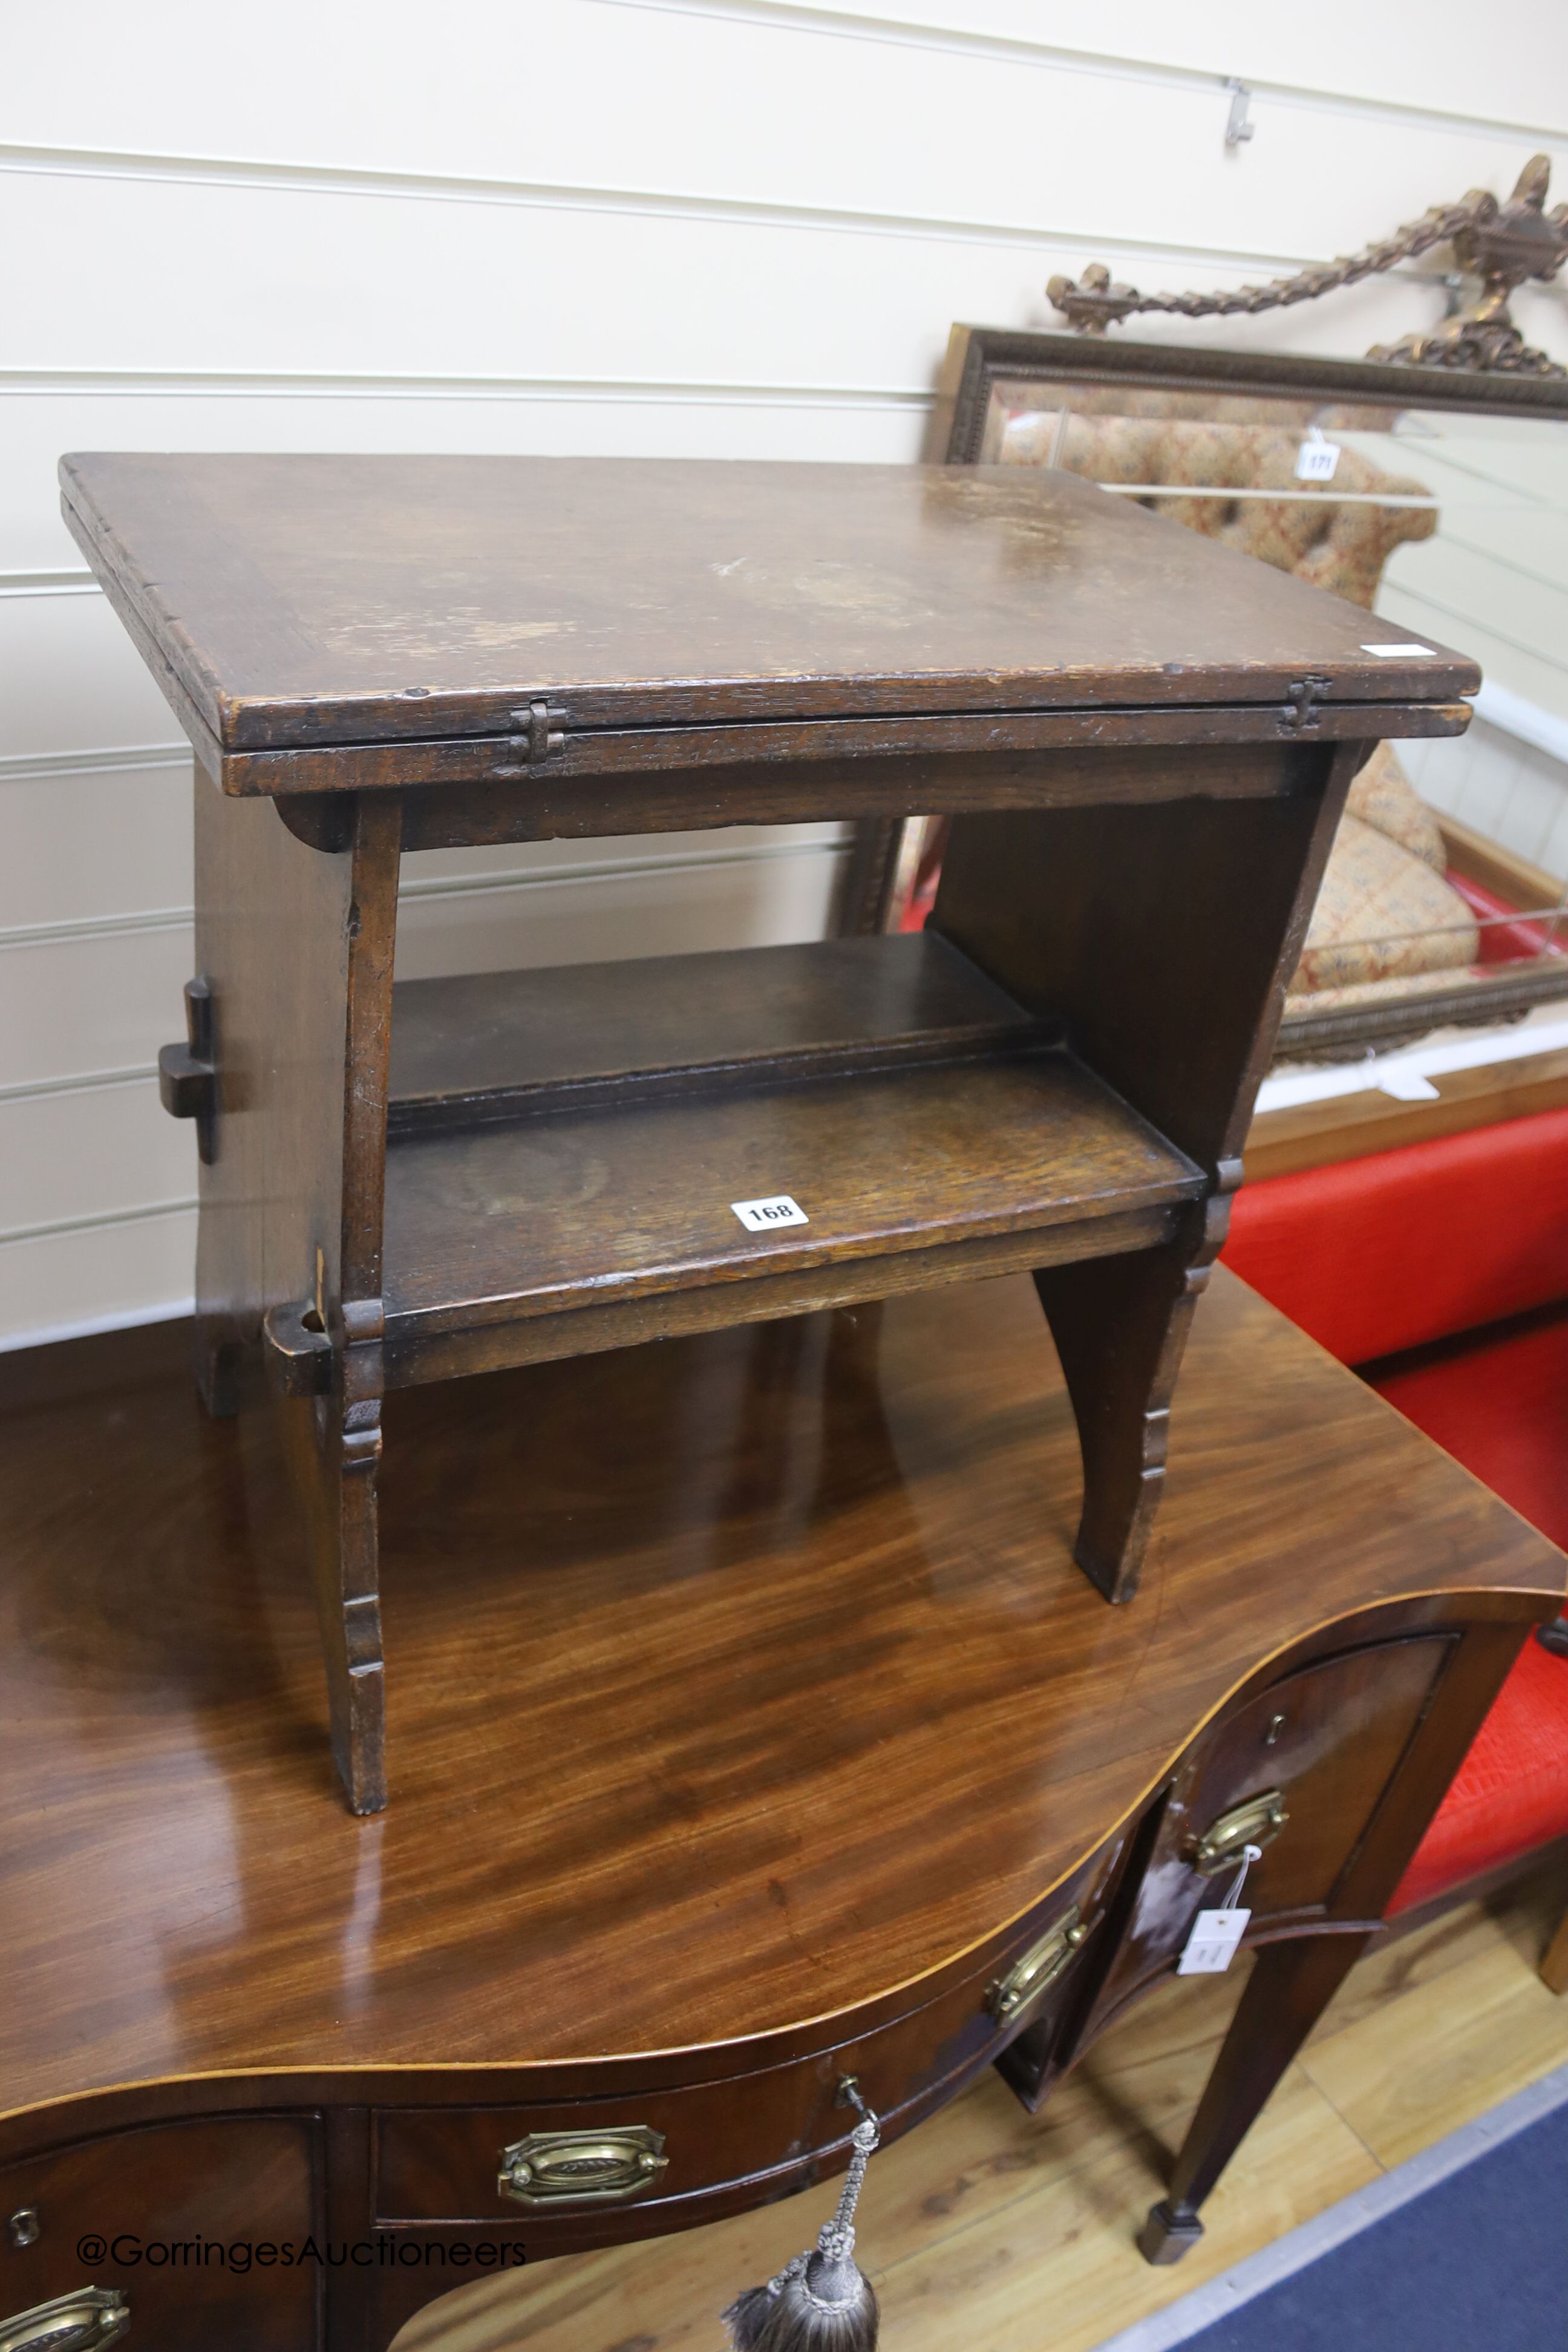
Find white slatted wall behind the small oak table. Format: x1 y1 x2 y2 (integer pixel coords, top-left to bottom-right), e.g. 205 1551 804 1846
0 0 1568 1343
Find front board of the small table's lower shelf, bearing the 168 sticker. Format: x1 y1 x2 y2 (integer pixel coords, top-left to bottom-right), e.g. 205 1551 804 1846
385 1049 1204 1338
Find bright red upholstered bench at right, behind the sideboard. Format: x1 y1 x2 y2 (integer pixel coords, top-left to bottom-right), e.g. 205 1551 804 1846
1225 1110 1568 1992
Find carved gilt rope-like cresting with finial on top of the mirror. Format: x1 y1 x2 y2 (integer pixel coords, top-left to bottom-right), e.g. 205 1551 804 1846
1046 155 1568 376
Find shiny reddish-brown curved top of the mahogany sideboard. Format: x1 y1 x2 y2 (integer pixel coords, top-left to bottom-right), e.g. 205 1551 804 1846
0 1272 1563 2110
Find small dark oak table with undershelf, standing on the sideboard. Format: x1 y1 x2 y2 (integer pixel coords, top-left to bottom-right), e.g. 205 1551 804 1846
61 456 1478 1814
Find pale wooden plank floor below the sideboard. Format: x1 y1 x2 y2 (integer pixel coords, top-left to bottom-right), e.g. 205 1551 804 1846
397 1880 1568 2352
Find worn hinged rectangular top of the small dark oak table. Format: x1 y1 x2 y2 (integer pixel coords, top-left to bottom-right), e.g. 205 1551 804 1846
61 454 1481 753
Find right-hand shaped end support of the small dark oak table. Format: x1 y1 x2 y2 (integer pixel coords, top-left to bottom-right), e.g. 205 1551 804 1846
931 739 1364 1602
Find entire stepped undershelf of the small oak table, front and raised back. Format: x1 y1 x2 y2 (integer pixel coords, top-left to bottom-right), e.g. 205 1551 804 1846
383 936 1204 1385
